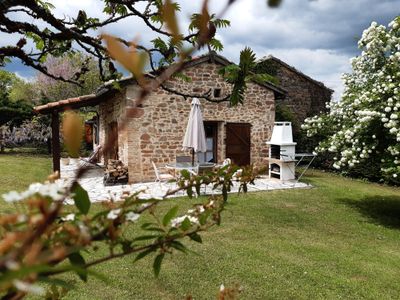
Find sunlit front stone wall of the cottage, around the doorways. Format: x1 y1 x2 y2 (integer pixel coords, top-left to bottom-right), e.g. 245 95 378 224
126 63 275 182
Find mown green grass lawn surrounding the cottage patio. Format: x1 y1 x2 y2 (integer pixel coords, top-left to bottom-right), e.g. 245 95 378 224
0 155 400 299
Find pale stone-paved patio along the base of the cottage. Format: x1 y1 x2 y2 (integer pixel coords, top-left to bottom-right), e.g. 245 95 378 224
61 161 312 202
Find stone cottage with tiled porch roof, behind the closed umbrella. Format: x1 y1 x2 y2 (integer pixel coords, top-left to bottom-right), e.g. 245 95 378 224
36 53 332 182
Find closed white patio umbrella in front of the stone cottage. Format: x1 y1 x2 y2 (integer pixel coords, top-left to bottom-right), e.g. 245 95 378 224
182 98 207 165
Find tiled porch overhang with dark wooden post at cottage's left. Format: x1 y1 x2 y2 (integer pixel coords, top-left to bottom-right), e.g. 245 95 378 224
34 89 115 173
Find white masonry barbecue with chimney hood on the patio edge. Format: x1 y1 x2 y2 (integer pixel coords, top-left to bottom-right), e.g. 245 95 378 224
267 122 297 180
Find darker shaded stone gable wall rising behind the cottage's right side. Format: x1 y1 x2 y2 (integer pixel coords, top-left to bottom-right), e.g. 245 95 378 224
273 61 332 123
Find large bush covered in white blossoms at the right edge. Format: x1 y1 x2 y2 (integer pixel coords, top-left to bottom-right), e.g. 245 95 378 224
302 16 400 184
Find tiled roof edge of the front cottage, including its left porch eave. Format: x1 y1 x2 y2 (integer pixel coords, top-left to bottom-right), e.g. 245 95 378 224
34 52 287 114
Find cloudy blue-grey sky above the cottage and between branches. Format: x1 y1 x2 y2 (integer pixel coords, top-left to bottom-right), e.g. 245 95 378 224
0 0 400 99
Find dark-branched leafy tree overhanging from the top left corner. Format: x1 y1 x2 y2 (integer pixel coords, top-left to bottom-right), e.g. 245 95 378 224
0 0 230 83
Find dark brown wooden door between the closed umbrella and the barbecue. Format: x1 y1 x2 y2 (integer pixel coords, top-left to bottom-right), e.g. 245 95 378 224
226 123 250 166
